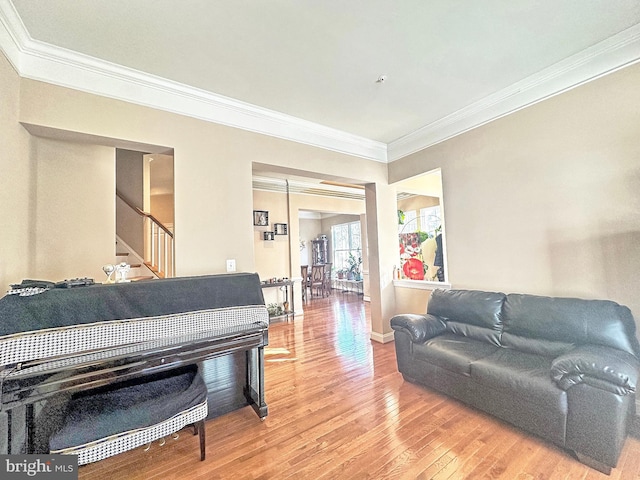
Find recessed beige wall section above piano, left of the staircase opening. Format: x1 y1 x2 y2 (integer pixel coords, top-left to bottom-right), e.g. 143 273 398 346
31 137 115 281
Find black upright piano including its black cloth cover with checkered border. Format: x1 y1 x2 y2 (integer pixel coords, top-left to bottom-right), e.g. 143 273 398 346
0 274 269 453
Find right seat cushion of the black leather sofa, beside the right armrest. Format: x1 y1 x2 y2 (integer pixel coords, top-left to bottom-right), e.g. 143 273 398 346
470 348 567 415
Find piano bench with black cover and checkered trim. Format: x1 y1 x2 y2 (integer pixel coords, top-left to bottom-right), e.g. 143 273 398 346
49 366 207 465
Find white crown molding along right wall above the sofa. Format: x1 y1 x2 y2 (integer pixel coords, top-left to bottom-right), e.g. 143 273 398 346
387 24 640 162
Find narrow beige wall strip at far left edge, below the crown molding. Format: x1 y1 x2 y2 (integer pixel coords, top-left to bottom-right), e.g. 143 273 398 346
0 52 36 288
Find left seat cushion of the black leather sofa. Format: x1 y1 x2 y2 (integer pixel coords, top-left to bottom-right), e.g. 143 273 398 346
413 333 500 375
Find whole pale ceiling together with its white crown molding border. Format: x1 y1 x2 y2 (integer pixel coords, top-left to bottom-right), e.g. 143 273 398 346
0 0 640 161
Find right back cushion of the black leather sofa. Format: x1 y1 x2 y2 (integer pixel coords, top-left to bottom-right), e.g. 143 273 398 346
502 294 640 356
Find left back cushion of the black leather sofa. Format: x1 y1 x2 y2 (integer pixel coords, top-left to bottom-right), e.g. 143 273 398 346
427 289 506 345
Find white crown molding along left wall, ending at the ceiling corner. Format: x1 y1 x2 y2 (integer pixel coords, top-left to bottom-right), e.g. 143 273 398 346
0 0 387 163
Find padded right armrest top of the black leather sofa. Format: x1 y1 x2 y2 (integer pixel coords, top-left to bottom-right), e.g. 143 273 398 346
551 345 640 395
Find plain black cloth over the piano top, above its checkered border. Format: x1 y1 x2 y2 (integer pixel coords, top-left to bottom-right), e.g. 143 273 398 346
0 273 264 337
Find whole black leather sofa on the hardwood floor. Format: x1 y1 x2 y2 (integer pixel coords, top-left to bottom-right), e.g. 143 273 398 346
391 290 640 473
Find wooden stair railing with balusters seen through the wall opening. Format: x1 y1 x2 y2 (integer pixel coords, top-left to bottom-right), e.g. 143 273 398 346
116 190 175 278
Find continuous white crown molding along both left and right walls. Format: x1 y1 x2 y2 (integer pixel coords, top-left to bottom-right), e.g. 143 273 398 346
0 0 640 163
